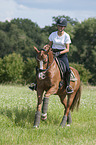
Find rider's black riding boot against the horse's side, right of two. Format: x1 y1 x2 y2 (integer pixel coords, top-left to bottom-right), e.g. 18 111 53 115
65 72 73 94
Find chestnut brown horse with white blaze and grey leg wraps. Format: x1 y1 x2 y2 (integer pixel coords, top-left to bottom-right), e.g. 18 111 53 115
34 45 81 127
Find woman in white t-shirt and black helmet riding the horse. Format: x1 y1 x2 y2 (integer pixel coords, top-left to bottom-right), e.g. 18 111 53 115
29 18 73 94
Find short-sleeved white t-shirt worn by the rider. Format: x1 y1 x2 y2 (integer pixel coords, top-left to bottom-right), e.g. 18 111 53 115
49 31 71 49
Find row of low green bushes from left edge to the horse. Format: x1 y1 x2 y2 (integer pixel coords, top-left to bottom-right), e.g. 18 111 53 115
0 53 36 84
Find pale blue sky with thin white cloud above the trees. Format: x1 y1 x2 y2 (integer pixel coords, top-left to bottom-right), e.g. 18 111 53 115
0 0 96 28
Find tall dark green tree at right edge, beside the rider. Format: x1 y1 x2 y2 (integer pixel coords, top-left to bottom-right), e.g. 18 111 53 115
73 18 96 83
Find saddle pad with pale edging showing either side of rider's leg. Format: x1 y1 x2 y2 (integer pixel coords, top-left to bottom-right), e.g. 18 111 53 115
55 57 77 82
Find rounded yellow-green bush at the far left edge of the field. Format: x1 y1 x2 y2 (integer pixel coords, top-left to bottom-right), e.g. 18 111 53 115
0 53 24 83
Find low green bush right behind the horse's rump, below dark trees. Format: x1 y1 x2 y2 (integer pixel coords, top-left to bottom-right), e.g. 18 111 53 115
70 63 92 83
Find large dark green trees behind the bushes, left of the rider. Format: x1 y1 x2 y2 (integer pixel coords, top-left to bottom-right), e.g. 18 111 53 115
0 18 48 60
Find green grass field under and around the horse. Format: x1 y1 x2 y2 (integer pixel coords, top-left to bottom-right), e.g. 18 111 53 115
0 85 96 145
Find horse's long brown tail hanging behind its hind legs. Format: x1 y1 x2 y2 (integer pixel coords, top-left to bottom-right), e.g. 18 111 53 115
70 84 81 111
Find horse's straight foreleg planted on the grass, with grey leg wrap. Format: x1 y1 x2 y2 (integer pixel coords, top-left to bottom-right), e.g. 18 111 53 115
33 93 43 128
